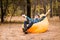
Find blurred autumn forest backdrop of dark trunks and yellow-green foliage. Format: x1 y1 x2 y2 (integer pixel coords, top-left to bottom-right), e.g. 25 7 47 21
0 0 60 23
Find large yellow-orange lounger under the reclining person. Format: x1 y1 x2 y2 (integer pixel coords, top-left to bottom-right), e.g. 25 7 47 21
22 14 49 33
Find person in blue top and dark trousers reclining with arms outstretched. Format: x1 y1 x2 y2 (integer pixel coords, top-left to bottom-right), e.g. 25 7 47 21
22 9 50 32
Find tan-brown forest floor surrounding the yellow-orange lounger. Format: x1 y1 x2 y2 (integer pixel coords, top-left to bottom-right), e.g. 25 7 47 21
0 17 60 40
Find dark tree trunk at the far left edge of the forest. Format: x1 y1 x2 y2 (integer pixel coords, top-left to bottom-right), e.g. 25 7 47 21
0 0 8 23
